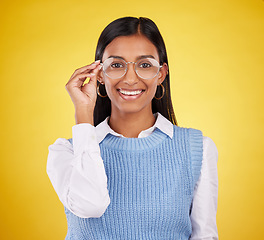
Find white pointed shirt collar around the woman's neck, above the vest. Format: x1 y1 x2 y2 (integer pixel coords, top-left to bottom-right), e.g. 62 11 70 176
96 113 173 143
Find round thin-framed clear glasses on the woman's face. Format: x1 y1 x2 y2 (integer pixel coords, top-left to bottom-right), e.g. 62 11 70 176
101 57 162 79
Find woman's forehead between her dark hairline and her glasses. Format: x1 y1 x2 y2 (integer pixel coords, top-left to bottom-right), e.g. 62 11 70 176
102 35 159 61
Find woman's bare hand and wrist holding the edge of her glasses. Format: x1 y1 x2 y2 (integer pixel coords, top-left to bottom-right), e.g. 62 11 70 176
65 60 101 125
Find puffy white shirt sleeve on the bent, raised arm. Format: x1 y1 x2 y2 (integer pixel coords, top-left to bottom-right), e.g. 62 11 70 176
47 123 110 218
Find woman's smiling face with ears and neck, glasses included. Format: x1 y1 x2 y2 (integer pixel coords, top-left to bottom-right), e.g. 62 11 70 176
97 33 168 132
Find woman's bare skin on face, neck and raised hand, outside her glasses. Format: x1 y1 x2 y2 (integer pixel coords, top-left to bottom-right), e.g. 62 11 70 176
65 34 168 138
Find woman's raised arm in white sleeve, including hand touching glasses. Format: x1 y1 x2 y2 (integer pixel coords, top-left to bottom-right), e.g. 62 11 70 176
47 62 110 218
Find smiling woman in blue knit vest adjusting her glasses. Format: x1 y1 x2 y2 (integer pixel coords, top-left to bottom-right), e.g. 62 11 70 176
47 17 218 240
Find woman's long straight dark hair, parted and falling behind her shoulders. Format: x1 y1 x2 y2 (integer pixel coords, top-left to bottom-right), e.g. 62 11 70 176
94 17 178 126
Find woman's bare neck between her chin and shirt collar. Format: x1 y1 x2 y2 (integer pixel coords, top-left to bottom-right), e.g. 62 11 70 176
109 106 156 138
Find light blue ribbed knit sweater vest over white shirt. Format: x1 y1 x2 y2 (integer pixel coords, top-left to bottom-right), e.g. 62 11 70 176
65 125 203 240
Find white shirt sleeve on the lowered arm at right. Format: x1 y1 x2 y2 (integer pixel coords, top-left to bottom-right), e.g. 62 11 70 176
190 137 218 240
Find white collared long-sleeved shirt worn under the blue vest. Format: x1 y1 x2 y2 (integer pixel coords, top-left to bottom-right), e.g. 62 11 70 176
47 113 218 240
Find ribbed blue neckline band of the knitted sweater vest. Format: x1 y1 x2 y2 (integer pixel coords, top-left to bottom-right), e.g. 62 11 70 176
100 128 169 151
